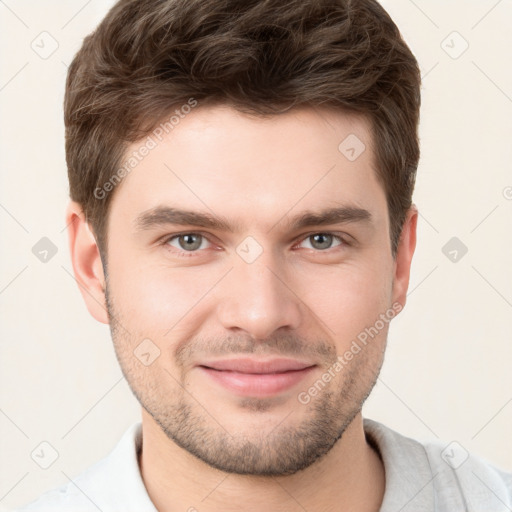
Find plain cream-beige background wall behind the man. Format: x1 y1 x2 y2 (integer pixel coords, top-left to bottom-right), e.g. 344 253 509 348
0 0 512 510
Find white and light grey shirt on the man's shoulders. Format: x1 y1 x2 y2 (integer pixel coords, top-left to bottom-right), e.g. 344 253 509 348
18 418 512 512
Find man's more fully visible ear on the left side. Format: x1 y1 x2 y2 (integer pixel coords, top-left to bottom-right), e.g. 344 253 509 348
66 201 109 324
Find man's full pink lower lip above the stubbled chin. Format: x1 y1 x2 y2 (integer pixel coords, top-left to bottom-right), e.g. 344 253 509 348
199 366 314 397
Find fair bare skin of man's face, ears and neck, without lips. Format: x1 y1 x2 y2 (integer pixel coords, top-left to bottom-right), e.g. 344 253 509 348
66 105 418 512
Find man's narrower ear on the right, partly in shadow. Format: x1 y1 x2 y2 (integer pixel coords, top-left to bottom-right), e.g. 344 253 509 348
393 205 418 307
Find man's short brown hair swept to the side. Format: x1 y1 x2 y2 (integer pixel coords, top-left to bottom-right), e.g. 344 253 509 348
64 0 421 264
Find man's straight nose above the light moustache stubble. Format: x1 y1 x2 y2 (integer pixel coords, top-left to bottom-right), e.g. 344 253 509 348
217 255 303 339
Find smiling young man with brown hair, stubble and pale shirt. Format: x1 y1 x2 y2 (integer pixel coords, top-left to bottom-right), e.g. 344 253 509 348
14 0 512 512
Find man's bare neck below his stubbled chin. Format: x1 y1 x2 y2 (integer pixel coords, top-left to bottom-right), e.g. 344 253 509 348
139 410 385 512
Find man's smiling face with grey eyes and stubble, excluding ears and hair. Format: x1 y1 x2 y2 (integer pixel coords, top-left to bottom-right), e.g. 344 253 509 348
103 106 408 475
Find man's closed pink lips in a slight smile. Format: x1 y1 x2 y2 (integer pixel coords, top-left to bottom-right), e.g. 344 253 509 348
199 358 316 397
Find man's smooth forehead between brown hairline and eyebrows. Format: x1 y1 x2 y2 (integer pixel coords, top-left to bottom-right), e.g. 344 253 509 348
111 105 386 233
